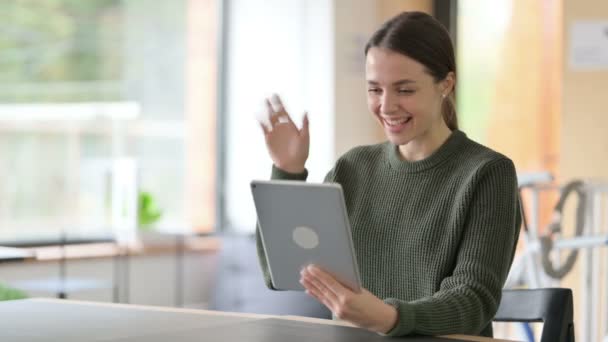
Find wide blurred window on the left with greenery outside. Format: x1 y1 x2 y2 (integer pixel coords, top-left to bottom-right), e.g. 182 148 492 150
0 0 217 240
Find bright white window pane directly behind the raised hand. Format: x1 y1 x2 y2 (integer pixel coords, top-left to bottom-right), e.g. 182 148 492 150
221 0 334 233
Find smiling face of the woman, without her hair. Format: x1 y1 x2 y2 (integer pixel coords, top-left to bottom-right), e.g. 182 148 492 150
365 47 453 145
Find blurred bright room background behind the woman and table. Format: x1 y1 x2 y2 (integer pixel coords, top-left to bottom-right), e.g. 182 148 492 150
0 0 608 341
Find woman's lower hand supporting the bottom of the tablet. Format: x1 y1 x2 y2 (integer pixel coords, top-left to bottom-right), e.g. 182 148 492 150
300 265 398 333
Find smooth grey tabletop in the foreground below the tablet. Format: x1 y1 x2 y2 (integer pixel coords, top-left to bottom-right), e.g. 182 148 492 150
0 299 516 342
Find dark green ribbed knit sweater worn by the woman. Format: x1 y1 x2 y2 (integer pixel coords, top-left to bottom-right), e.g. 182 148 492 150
256 130 521 336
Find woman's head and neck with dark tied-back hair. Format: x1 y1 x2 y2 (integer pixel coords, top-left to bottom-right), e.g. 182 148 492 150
365 15 458 161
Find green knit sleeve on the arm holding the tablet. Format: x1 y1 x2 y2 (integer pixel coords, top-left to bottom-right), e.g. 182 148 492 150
384 159 521 336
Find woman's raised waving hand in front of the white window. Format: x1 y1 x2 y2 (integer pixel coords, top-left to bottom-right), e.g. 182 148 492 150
260 95 310 173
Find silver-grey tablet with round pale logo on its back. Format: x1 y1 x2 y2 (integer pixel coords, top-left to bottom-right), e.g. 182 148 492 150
251 180 361 292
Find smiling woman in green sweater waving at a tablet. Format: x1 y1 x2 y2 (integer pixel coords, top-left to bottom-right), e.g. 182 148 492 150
257 12 521 336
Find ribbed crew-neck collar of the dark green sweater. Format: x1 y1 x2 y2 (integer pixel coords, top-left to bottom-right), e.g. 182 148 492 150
386 130 467 173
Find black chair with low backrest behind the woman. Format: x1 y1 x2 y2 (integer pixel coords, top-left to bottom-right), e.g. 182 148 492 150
494 288 574 342
